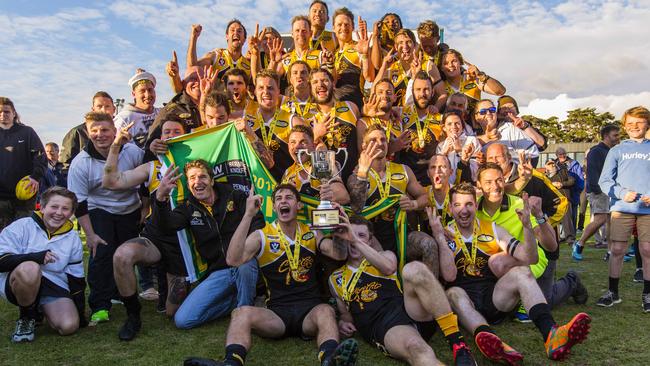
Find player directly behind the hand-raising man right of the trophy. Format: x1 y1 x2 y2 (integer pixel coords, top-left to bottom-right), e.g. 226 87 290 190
357 79 411 157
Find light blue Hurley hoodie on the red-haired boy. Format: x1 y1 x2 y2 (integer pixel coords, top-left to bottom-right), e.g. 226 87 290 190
598 139 650 215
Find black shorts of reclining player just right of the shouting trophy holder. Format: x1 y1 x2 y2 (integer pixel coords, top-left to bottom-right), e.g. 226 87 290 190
357 297 438 355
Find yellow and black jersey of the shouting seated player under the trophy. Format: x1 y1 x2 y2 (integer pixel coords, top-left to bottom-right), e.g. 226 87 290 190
257 222 320 306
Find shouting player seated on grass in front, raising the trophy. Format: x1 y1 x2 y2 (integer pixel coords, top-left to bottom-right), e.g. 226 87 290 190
185 184 358 366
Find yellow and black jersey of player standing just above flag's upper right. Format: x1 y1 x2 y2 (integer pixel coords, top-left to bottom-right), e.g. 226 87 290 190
244 103 293 180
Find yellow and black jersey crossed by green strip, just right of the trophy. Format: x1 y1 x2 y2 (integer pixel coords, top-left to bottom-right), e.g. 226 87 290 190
366 161 409 252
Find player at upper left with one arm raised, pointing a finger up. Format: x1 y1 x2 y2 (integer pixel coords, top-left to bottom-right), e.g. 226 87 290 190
187 19 251 80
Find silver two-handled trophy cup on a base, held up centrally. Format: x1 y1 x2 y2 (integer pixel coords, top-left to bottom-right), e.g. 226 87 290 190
297 148 348 230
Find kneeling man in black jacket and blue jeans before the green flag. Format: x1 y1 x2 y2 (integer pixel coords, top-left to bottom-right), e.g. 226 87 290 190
152 159 265 329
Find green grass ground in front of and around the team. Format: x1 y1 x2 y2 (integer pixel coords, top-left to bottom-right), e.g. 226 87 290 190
0 239 650 366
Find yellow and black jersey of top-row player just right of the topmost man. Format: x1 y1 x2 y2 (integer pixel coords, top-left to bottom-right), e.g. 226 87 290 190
334 44 366 109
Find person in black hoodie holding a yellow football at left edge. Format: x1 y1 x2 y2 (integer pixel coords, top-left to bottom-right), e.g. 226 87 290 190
0 97 47 230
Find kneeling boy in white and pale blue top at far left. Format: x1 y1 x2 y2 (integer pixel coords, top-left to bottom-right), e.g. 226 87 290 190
0 187 86 342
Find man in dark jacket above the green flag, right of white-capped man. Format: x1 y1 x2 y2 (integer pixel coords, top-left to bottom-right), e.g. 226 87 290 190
146 66 202 160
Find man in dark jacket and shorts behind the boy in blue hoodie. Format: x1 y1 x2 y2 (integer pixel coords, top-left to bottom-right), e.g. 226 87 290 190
572 124 621 261
